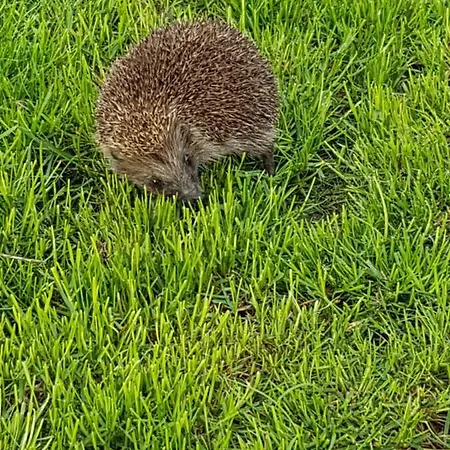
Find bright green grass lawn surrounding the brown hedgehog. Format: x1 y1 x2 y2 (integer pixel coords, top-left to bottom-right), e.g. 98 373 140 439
0 0 450 450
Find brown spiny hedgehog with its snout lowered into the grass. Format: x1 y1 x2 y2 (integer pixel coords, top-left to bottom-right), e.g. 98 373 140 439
96 19 279 201
